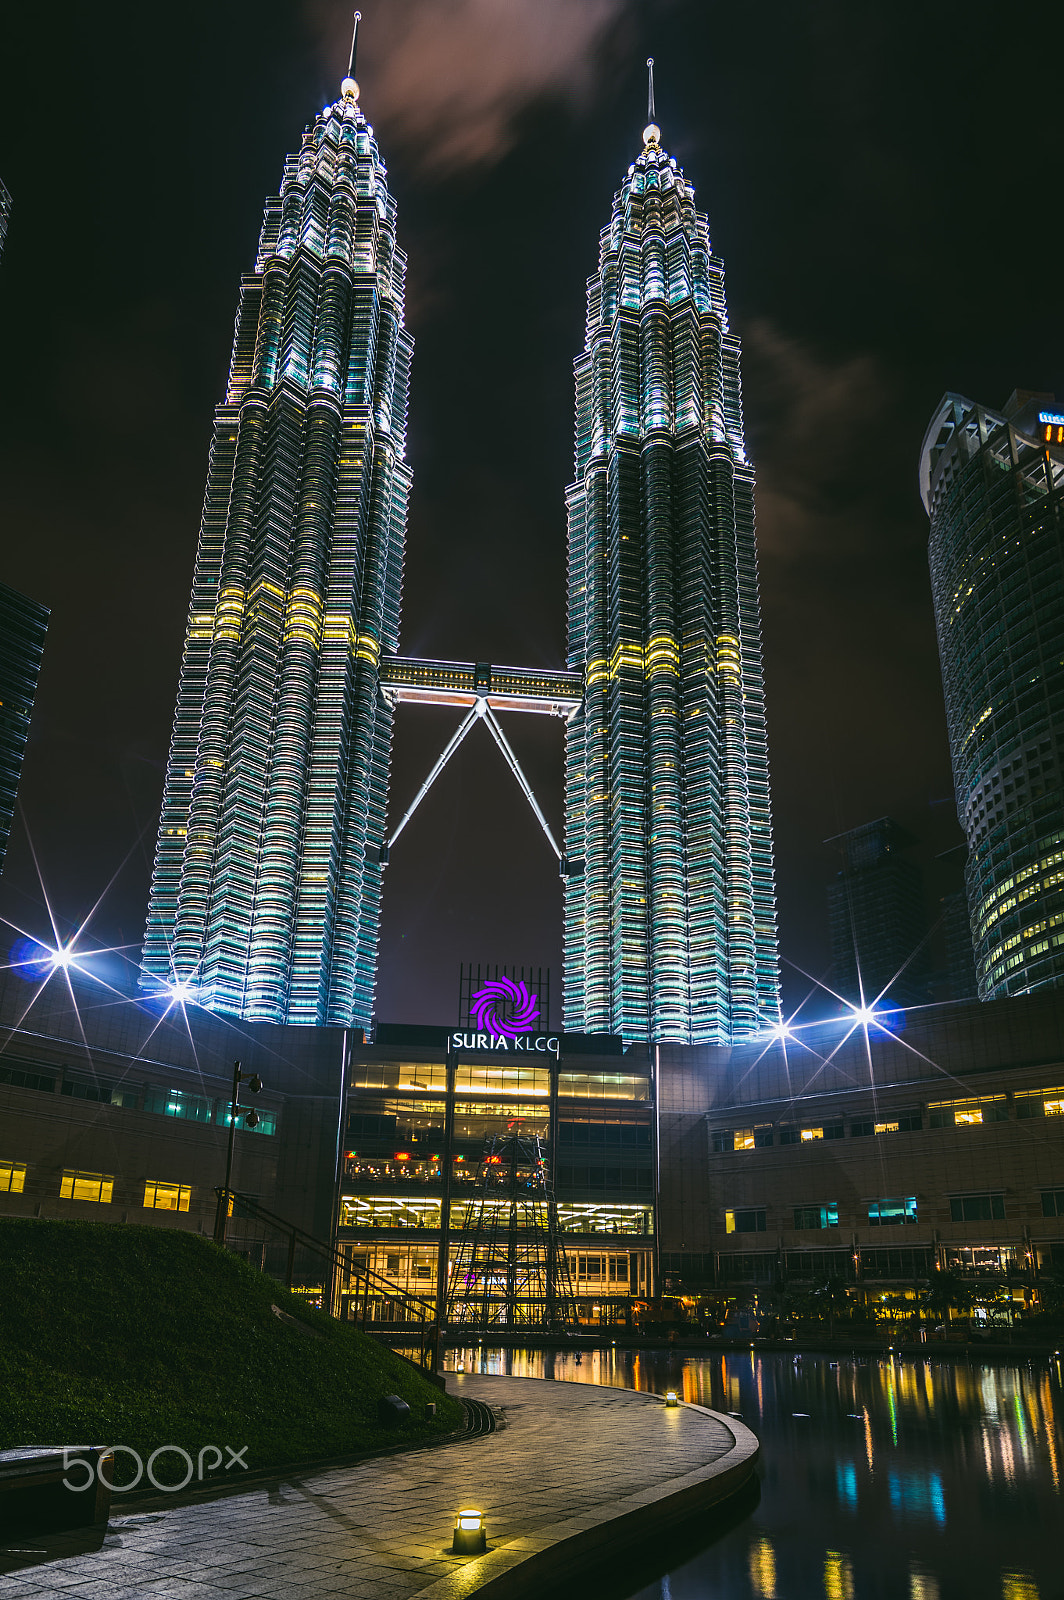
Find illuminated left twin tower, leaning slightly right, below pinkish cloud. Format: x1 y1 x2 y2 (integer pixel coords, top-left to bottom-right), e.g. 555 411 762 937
141 68 413 1026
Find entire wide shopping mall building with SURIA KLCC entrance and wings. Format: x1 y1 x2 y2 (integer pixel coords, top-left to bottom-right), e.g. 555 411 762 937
0 973 1064 1326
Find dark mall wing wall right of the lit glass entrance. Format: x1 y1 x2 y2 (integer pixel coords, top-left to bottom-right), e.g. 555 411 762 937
659 992 1064 1286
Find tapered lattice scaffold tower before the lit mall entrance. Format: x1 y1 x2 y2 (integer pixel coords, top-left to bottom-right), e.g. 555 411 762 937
446 1131 578 1333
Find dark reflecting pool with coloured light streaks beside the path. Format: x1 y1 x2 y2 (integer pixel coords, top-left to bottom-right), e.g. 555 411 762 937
446 1346 1064 1600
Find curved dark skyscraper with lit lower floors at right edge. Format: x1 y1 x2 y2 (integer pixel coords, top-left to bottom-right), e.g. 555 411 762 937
920 392 1064 1000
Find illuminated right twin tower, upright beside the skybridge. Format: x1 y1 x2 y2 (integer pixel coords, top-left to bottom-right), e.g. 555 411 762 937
563 112 779 1043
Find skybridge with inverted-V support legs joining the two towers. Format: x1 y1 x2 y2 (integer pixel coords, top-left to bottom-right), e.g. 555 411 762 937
379 656 584 877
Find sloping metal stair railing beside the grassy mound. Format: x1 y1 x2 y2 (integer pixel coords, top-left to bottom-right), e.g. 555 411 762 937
214 1189 440 1373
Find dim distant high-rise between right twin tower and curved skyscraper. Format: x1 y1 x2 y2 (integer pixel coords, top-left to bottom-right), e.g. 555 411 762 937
826 816 931 1005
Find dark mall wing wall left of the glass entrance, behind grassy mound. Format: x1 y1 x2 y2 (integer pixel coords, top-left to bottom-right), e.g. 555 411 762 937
0 971 346 1262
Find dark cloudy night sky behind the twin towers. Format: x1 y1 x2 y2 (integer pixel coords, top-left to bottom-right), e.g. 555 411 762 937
0 0 1064 1024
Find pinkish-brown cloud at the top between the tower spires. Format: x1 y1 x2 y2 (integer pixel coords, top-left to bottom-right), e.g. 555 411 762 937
309 0 629 173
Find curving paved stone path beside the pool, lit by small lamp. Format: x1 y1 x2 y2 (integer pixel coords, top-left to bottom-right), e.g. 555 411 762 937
0 1374 745 1600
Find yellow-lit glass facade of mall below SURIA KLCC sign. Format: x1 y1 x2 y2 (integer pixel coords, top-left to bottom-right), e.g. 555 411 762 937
336 1042 656 1326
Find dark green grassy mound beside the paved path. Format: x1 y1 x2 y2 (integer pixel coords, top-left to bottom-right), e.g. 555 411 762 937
0 1218 462 1482
